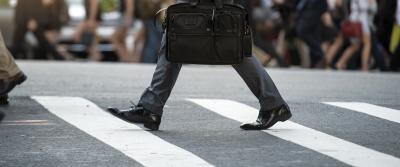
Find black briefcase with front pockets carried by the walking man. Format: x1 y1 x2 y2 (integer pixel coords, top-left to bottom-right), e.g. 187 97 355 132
165 0 252 65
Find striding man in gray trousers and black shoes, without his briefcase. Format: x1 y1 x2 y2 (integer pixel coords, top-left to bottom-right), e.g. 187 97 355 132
108 0 292 130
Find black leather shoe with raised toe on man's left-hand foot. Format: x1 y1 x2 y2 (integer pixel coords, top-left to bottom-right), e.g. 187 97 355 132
107 106 161 130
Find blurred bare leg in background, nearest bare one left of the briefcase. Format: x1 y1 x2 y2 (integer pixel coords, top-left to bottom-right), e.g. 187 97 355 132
110 0 138 62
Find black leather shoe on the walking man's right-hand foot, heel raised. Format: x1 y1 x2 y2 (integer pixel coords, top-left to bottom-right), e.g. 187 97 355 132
240 105 292 130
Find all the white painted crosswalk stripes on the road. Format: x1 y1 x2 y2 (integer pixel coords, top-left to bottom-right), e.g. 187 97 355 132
28 96 400 167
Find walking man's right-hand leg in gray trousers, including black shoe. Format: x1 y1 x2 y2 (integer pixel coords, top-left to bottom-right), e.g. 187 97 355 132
233 56 292 130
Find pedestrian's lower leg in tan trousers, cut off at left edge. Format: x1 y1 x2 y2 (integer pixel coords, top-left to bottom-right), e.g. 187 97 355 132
0 32 27 105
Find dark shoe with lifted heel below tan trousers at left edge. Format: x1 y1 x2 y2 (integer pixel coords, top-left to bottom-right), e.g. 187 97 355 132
0 72 27 96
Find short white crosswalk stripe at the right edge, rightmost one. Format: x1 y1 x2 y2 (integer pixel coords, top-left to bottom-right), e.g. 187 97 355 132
324 102 400 123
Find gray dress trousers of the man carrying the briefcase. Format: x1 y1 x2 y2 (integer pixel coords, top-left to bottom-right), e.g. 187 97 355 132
139 35 287 115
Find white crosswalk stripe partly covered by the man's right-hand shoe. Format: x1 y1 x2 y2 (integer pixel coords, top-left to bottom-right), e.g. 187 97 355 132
188 99 400 167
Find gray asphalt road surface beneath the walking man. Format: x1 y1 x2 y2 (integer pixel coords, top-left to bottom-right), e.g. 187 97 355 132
0 61 400 167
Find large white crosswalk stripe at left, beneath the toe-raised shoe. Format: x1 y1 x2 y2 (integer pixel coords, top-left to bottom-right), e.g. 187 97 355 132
32 96 213 167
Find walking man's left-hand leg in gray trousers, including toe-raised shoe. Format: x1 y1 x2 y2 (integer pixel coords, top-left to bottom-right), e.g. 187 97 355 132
108 36 182 130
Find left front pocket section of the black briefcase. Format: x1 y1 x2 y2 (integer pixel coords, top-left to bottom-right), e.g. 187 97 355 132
167 13 214 64
